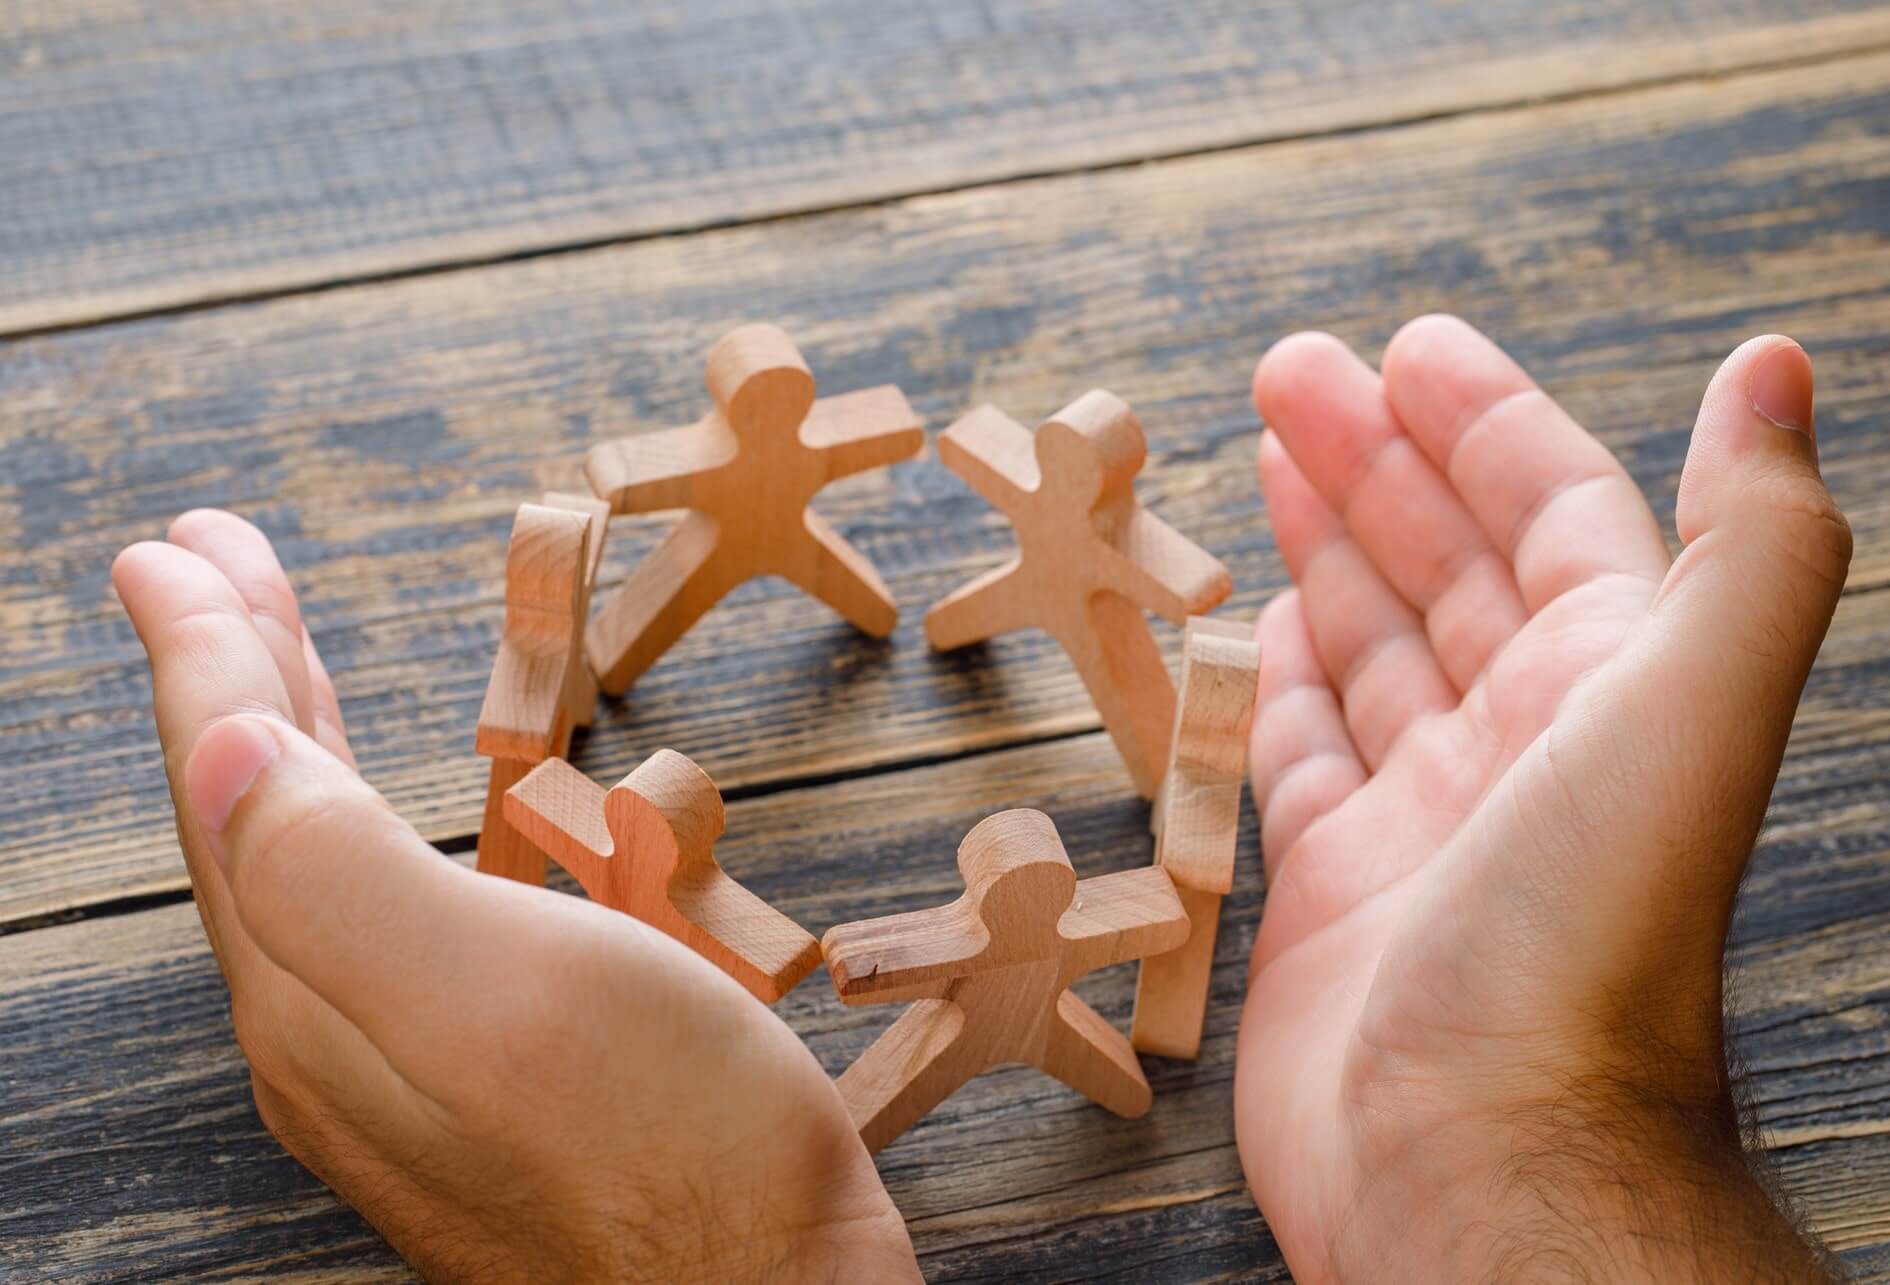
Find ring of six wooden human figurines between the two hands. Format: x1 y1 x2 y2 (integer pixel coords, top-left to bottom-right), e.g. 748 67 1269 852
476 325 1259 1151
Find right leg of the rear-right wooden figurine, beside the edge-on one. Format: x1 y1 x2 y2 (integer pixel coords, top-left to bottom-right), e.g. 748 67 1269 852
1058 593 1176 799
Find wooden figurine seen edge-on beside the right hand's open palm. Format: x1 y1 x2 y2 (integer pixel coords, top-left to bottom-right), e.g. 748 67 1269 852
1128 616 1261 1058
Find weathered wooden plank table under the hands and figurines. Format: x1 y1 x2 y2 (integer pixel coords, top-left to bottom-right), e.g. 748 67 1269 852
0 0 1890 1279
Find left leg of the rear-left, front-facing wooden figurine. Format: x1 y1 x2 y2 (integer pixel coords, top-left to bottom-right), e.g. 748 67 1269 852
584 512 735 695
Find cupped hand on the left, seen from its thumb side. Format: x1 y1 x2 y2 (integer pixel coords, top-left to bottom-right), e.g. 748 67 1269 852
112 510 919 1281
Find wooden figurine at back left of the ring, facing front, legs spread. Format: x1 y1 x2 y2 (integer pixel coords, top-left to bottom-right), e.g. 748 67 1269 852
584 325 924 694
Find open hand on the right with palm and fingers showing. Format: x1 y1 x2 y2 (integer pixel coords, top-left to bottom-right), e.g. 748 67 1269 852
1236 317 1850 1281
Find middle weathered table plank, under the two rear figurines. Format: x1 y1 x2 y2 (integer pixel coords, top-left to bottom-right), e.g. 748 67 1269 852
0 57 1890 922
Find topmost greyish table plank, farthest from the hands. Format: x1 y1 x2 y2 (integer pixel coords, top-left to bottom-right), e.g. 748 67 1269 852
0 0 1890 333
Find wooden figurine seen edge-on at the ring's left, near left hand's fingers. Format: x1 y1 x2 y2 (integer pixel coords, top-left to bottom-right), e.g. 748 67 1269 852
474 491 610 884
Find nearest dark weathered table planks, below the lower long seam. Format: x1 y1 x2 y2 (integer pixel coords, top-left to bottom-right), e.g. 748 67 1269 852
0 718 1890 1281
